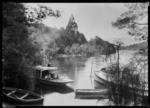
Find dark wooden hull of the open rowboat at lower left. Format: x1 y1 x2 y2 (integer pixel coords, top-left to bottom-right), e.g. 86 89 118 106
2 87 44 104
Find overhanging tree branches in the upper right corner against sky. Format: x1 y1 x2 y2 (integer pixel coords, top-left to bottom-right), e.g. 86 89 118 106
112 3 149 40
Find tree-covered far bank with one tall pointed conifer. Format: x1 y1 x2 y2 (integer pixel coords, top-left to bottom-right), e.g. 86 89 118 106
28 15 115 57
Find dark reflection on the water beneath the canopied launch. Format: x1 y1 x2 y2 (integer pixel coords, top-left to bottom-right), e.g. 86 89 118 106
34 84 74 95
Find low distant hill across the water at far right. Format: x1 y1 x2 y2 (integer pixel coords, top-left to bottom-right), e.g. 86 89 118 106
121 42 148 50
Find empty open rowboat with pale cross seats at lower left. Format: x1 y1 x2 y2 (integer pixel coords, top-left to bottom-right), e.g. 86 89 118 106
2 87 43 104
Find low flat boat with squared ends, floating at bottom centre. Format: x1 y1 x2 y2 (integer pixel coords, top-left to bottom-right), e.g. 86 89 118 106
75 89 107 99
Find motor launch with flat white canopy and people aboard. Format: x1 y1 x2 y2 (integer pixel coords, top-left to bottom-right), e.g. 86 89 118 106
35 66 73 85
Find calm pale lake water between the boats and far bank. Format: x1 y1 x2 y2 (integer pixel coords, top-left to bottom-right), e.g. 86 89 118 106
3 51 140 106
